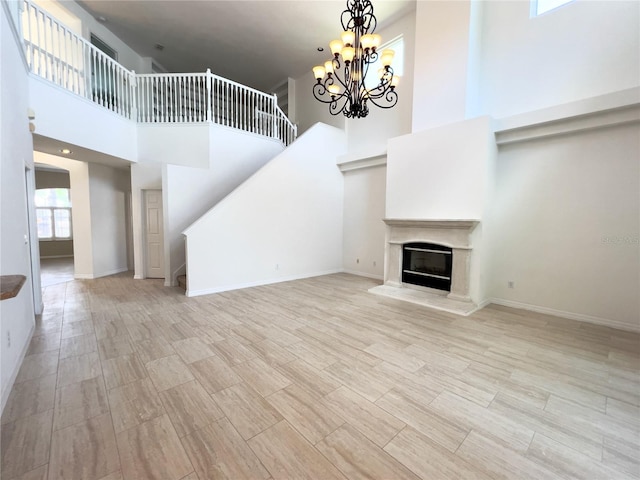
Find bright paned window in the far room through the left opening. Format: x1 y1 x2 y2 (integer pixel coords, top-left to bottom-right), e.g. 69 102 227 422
35 188 71 240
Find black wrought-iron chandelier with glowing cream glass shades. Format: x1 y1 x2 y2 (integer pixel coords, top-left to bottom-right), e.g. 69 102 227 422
313 0 399 118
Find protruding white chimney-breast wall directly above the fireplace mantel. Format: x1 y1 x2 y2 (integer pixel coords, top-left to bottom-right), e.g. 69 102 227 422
386 117 495 220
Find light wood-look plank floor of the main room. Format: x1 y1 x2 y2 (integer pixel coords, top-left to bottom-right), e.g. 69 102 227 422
2 274 640 480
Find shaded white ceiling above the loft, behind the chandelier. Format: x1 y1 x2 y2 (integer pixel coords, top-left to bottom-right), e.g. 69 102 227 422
79 0 416 91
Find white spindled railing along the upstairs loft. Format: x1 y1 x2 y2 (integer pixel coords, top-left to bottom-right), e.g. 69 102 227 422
21 0 297 145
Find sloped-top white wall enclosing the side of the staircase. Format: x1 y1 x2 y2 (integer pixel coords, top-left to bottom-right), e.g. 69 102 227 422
185 124 346 295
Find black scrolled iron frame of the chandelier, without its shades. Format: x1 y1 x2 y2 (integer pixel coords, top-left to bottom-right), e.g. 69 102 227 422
313 0 398 118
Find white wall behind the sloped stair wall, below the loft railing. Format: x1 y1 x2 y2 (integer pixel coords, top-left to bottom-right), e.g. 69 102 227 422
163 125 283 284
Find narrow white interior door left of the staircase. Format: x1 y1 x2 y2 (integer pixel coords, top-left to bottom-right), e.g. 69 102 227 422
144 190 164 278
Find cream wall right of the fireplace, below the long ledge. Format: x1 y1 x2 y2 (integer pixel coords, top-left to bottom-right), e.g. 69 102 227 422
490 124 640 330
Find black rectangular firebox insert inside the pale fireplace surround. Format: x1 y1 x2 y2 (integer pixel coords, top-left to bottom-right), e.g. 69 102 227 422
402 242 452 292
